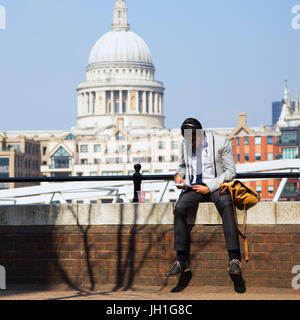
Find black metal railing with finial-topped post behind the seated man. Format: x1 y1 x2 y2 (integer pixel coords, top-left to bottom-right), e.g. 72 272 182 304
0 164 300 202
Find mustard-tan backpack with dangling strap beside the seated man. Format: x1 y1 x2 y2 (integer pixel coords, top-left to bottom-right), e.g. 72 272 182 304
220 180 260 262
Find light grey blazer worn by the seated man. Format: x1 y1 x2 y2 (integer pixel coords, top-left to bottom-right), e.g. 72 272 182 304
175 130 236 192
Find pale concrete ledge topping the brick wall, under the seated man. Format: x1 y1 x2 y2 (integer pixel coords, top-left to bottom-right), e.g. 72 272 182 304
0 202 300 226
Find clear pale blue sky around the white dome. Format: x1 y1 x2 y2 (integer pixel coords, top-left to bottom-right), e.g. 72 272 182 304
0 0 300 131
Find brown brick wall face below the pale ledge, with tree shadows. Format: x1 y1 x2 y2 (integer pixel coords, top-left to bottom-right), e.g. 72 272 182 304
0 224 300 288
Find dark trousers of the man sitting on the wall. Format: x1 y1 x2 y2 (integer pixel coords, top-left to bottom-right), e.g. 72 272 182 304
174 190 240 251
